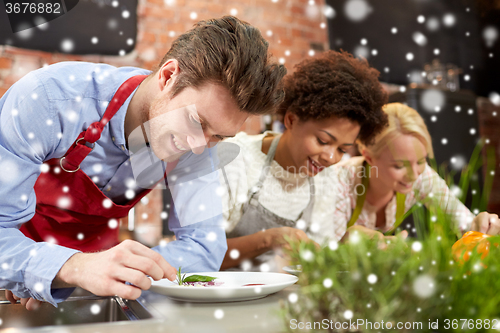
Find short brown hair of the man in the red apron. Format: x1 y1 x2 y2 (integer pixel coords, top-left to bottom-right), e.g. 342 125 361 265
157 16 286 114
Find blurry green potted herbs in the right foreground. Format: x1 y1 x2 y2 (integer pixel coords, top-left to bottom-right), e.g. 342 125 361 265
282 146 500 332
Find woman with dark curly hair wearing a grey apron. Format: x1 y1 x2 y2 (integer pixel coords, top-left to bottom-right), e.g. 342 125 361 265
221 51 387 269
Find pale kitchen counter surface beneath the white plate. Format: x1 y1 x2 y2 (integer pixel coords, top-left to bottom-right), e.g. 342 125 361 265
0 285 299 333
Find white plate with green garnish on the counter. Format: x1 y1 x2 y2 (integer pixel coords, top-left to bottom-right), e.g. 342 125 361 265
150 272 298 302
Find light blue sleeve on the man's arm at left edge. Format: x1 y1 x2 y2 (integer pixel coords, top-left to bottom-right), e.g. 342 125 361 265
0 74 78 305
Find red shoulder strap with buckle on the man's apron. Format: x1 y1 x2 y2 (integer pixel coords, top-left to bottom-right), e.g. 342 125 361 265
59 75 147 172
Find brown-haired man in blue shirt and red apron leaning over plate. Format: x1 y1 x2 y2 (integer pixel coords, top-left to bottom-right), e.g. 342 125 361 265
0 17 285 308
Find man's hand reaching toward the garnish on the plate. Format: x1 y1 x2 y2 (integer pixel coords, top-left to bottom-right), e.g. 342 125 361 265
53 240 177 299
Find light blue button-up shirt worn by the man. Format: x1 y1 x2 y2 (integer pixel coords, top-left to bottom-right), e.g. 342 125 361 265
0 62 227 305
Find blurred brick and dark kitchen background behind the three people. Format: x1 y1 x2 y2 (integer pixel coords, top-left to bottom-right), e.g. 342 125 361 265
0 0 500 245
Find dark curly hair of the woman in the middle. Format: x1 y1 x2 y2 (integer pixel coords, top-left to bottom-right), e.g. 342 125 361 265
278 51 388 145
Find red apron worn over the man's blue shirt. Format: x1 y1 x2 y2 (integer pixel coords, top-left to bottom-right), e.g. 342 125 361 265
21 75 177 252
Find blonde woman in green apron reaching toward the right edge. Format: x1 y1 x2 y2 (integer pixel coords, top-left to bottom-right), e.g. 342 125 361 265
334 103 500 236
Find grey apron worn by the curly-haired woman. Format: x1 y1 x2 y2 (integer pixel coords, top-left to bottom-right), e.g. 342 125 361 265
227 135 314 267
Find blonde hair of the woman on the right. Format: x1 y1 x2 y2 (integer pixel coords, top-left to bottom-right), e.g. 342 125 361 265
358 103 434 158
